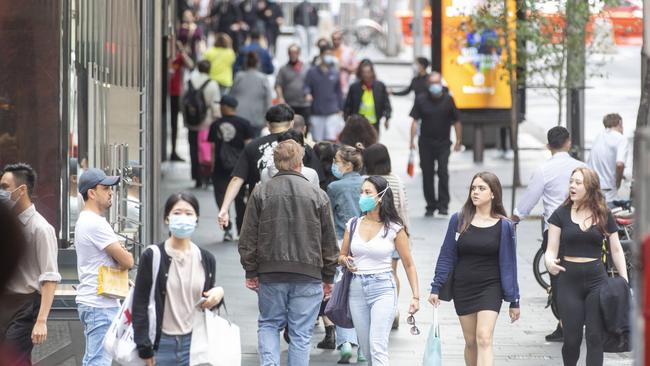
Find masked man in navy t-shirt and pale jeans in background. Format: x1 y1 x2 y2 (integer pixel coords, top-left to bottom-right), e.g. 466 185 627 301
305 42 343 142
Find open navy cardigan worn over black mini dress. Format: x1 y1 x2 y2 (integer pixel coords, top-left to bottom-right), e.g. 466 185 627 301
431 213 519 307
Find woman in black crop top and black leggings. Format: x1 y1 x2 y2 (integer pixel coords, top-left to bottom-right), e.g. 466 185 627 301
545 168 628 366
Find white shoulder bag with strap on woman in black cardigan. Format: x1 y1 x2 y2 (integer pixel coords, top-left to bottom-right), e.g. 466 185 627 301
103 245 160 366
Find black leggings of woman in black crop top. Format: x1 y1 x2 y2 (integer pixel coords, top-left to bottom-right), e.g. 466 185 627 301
557 260 607 366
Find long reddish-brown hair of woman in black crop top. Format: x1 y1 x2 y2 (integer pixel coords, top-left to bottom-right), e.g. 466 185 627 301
562 168 611 234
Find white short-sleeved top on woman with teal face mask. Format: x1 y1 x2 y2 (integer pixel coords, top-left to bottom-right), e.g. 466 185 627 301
345 216 402 274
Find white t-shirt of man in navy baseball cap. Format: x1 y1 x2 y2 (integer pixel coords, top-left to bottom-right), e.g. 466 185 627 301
74 210 120 308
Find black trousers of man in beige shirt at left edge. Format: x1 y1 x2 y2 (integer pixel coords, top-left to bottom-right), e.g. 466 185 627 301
0 293 41 366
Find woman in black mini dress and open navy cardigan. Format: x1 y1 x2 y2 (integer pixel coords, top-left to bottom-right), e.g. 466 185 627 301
429 172 519 366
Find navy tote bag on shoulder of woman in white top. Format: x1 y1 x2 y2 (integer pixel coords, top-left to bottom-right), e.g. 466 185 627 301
325 217 359 328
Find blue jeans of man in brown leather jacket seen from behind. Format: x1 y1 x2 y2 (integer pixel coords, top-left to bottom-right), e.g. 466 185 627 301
257 282 323 366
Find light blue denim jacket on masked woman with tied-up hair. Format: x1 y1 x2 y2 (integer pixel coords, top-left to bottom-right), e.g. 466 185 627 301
327 172 363 240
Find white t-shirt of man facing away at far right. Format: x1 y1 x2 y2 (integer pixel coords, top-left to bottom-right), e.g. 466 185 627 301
588 128 630 202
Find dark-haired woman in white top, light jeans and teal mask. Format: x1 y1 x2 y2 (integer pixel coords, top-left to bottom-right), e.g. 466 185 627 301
339 176 420 366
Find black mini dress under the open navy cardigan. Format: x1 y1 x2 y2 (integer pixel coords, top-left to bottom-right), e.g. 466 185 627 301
453 220 503 316
